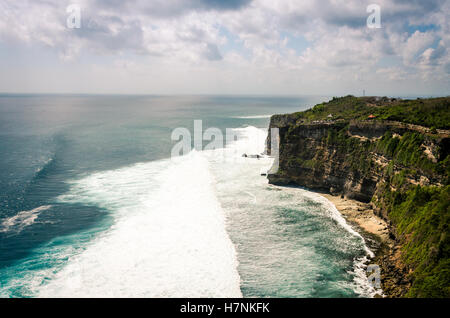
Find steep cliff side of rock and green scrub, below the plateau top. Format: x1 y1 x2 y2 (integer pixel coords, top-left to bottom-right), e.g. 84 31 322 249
267 97 450 297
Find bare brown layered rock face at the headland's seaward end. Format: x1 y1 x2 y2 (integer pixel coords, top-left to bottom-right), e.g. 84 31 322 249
267 115 448 202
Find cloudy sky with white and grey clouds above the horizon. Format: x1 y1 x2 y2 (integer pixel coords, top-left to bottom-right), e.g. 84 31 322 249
0 0 450 96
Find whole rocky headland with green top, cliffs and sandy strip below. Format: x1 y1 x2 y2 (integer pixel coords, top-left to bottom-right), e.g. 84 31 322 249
267 96 450 297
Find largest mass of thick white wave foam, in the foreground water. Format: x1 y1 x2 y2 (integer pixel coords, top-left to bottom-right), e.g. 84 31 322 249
38 151 242 297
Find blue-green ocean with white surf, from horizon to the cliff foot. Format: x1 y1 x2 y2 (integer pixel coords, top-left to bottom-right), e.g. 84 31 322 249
0 95 374 297
